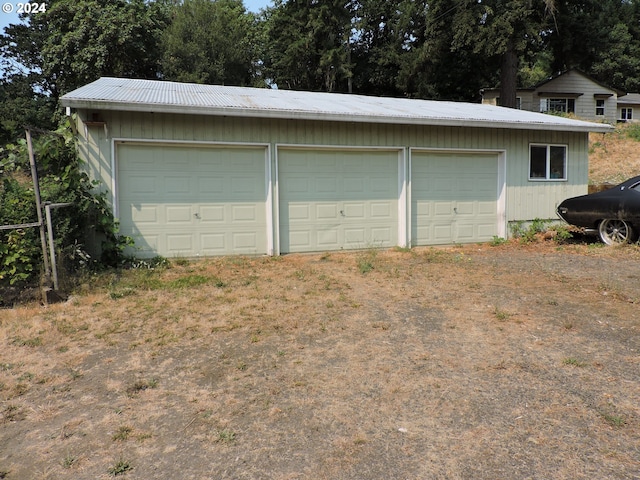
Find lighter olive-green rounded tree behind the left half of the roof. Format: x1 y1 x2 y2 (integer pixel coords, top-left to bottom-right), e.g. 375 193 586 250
162 0 258 86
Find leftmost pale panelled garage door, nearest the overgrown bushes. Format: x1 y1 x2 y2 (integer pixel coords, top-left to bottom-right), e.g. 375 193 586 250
117 143 267 257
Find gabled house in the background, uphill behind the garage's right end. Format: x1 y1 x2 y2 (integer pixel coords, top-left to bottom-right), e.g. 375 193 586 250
481 69 637 124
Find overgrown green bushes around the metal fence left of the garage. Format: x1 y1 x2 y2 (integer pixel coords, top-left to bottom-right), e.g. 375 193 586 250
0 120 130 300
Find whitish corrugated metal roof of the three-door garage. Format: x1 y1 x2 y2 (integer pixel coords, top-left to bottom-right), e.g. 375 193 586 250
60 77 613 132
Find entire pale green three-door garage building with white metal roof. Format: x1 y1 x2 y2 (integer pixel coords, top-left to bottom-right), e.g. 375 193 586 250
61 78 612 257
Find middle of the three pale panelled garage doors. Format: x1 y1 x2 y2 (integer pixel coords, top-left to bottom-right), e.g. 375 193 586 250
278 148 398 253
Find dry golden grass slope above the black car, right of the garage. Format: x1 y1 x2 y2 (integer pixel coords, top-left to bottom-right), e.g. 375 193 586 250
589 124 640 184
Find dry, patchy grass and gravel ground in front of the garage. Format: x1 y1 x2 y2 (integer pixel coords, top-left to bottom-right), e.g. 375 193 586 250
0 241 640 480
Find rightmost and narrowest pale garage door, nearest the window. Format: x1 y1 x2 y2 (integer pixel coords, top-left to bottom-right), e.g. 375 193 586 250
411 152 498 245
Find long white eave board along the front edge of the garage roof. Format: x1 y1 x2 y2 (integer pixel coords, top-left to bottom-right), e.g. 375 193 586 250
61 97 613 133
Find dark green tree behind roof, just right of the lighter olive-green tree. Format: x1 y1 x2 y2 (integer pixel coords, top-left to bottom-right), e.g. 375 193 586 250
264 0 354 92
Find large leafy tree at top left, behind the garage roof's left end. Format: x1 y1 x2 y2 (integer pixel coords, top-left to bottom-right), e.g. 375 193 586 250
0 0 168 100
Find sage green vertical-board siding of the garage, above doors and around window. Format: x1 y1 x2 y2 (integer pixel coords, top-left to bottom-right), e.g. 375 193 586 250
78 111 588 228
